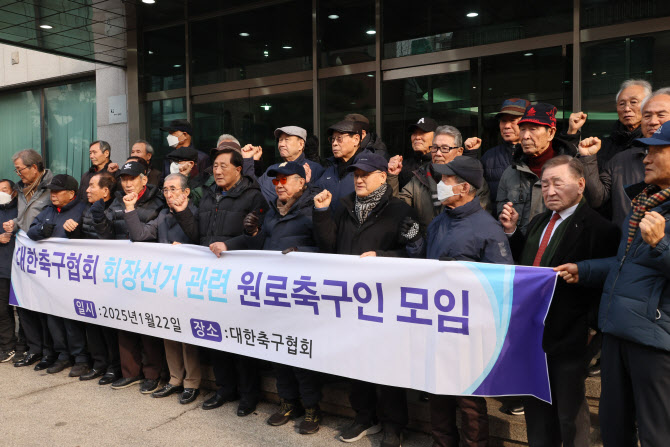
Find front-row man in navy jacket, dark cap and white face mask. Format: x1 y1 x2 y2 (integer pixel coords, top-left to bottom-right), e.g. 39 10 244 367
402 157 514 445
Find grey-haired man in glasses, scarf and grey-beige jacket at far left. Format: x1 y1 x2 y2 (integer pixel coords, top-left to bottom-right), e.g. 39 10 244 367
2 149 55 371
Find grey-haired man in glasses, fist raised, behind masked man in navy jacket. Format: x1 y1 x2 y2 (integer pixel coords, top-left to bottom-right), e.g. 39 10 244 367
388 126 491 233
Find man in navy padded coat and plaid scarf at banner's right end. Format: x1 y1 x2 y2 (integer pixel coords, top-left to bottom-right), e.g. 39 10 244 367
554 121 670 446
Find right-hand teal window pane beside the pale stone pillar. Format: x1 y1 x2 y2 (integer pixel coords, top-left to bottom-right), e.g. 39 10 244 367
44 81 98 180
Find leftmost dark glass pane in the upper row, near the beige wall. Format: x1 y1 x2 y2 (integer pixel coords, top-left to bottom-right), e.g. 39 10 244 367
141 26 186 92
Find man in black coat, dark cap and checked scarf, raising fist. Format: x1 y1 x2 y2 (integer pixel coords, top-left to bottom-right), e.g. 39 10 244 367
313 154 420 447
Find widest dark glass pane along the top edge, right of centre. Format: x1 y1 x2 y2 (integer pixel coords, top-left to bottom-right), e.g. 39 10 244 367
382 0 573 58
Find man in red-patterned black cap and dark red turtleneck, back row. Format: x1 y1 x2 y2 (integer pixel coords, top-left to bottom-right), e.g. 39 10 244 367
496 102 577 234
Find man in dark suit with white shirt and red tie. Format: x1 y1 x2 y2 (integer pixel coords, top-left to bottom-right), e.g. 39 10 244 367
500 155 619 447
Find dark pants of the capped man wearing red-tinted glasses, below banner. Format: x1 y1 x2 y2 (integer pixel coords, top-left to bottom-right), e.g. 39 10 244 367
274 363 321 408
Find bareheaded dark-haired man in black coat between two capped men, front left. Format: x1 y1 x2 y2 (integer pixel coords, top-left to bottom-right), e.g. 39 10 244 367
63 170 121 385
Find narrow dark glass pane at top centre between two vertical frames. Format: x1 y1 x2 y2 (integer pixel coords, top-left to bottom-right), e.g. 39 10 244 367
317 0 375 67
